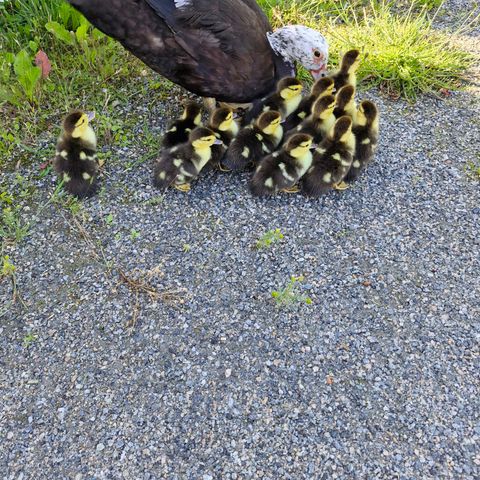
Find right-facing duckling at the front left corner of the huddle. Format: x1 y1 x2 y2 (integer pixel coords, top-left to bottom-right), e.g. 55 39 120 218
153 127 222 192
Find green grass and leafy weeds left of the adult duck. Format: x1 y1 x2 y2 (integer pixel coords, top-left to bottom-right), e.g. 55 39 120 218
0 0 170 169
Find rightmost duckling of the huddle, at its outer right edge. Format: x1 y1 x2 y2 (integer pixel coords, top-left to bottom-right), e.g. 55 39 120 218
345 100 379 182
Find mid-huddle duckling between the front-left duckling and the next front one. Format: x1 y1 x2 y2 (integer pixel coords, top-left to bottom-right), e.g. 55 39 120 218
224 110 283 171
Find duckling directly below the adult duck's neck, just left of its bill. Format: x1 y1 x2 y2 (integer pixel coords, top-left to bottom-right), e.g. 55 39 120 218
248 77 303 123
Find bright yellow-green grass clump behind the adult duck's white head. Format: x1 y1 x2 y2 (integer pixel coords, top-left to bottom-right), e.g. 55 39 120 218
262 0 474 101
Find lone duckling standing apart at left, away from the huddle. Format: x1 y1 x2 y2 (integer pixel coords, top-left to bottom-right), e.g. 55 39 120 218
53 110 101 198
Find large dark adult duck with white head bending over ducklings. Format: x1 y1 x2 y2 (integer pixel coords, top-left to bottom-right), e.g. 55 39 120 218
69 0 328 103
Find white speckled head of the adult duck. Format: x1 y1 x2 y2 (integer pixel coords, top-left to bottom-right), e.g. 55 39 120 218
267 25 328 80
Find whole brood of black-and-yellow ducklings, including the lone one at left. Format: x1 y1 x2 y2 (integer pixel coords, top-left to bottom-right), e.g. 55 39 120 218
54 50 379 197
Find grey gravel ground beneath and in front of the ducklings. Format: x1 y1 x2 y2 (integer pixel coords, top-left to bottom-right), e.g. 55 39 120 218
0 8 480 480
